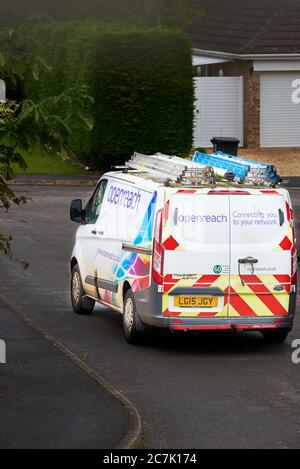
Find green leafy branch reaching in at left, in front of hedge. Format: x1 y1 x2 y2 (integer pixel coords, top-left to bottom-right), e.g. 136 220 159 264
0 87 93 254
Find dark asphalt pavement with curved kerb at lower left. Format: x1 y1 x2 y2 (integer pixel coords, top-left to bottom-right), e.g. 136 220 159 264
0 303 128 449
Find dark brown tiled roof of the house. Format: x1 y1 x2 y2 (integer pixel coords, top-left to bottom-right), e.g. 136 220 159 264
187 0 300 54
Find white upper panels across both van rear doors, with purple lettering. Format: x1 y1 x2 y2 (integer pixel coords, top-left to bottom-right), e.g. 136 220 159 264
169 194 287 250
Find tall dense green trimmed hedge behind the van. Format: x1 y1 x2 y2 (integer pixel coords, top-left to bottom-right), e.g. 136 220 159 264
25 22 194 166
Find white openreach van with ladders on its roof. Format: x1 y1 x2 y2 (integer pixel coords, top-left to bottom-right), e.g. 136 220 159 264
71 154 297 343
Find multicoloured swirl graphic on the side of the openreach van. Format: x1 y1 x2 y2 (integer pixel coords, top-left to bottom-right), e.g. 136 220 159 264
110 192 157 298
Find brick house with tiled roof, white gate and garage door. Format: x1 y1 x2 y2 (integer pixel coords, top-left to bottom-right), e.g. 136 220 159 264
187 0 300 149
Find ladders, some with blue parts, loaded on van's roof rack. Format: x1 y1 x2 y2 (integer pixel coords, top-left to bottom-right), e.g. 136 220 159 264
125 152 281 187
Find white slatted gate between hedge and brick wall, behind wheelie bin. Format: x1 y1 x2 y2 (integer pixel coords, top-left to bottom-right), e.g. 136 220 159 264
194 77 244 148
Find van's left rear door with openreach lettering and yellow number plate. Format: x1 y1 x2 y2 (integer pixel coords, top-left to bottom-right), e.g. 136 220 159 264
163 190 230 317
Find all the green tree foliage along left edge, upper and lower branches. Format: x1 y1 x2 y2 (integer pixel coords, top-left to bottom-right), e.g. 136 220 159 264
0 30 93 255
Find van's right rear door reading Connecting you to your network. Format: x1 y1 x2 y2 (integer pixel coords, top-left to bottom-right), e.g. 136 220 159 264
228 190 293 317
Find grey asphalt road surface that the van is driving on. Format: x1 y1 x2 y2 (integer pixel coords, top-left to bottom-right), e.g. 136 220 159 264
0 187 300 448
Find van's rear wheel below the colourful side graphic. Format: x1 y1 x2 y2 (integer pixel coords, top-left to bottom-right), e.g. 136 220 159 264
123 290 145 344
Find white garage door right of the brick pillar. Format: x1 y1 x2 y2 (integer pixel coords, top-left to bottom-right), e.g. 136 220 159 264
260 72 300 147
